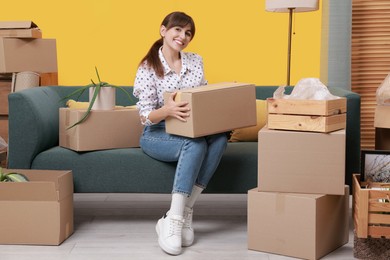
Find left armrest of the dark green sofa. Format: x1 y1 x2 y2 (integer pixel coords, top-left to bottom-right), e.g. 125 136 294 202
8 87 64 169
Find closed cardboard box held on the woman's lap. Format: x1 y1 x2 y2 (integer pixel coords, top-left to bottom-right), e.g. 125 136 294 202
164 83 256 137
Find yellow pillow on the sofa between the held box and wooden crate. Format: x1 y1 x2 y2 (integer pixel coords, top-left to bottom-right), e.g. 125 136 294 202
229 99 267 142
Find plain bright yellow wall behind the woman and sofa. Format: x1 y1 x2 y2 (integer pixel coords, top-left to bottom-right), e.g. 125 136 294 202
0 0 321 85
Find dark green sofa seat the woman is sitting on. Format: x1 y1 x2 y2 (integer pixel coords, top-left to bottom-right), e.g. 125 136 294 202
31 142 257 193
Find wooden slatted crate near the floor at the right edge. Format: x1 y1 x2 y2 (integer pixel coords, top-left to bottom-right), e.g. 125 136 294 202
352 174 390 239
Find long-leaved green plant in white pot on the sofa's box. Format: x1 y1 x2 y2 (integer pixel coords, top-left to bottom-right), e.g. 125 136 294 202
61 67 133 129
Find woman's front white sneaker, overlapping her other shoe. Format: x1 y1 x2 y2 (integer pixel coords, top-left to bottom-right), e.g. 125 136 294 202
156 214 184 255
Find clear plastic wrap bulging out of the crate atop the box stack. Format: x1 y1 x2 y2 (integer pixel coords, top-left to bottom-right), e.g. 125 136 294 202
274 78 340 100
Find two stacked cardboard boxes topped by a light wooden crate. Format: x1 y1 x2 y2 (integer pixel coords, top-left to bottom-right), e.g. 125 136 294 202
248 98 349 259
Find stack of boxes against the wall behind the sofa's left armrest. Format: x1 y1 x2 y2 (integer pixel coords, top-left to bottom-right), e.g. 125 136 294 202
0 21 58 145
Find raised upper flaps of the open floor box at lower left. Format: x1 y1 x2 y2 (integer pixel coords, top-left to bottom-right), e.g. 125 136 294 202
0 169 73 201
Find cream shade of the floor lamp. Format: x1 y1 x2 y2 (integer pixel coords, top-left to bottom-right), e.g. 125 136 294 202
265 0 318 13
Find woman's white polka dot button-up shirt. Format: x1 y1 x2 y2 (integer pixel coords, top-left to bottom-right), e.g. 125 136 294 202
133 48 207 125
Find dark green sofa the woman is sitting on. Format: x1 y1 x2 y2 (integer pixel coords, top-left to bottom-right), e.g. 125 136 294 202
8 86 360 193
